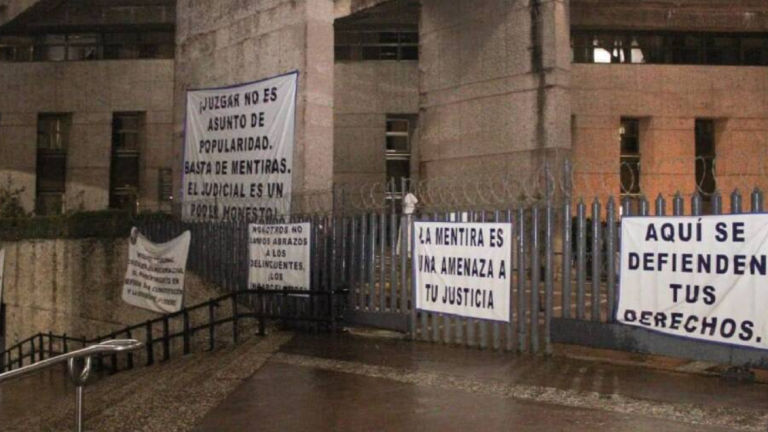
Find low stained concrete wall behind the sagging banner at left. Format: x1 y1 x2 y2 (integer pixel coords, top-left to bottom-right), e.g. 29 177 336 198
1 239 220 346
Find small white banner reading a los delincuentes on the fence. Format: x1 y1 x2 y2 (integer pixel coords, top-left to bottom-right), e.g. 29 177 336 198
248 223 312 291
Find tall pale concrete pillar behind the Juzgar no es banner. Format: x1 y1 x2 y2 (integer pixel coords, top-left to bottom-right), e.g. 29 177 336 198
175 0 334 191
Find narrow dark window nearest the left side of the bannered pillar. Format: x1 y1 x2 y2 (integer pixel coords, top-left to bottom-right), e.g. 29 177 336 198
109 113 144 211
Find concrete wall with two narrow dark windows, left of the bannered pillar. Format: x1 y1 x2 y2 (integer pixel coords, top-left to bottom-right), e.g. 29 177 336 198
0 60 173 211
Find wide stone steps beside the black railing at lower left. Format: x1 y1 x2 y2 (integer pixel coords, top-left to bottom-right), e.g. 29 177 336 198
0 329 291 432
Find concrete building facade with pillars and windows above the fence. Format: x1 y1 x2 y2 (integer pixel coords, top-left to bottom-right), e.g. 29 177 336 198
0 0 768 214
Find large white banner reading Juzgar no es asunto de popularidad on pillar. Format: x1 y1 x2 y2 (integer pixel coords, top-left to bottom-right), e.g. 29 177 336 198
182 72 298 220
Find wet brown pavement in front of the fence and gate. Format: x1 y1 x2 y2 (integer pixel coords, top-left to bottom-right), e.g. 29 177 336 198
195 335 768 432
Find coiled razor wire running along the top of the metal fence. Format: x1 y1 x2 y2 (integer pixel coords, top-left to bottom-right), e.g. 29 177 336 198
177 147 768 219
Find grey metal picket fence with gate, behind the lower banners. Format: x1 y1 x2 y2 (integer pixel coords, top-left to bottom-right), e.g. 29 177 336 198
6 160 768 372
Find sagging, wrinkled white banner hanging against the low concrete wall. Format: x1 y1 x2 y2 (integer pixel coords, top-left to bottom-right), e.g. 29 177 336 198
123 228 192 313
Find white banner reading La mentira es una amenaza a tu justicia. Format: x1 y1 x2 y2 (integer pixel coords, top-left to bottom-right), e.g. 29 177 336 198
413 222 512 322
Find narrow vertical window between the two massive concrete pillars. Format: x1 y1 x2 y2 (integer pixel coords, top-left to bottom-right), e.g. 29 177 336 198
386 116 411 200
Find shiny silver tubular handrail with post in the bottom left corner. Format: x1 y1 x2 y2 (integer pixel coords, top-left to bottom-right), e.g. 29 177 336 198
0 339 142 432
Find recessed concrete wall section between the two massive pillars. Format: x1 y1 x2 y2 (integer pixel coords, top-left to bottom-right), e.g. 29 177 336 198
333 61 419 183
